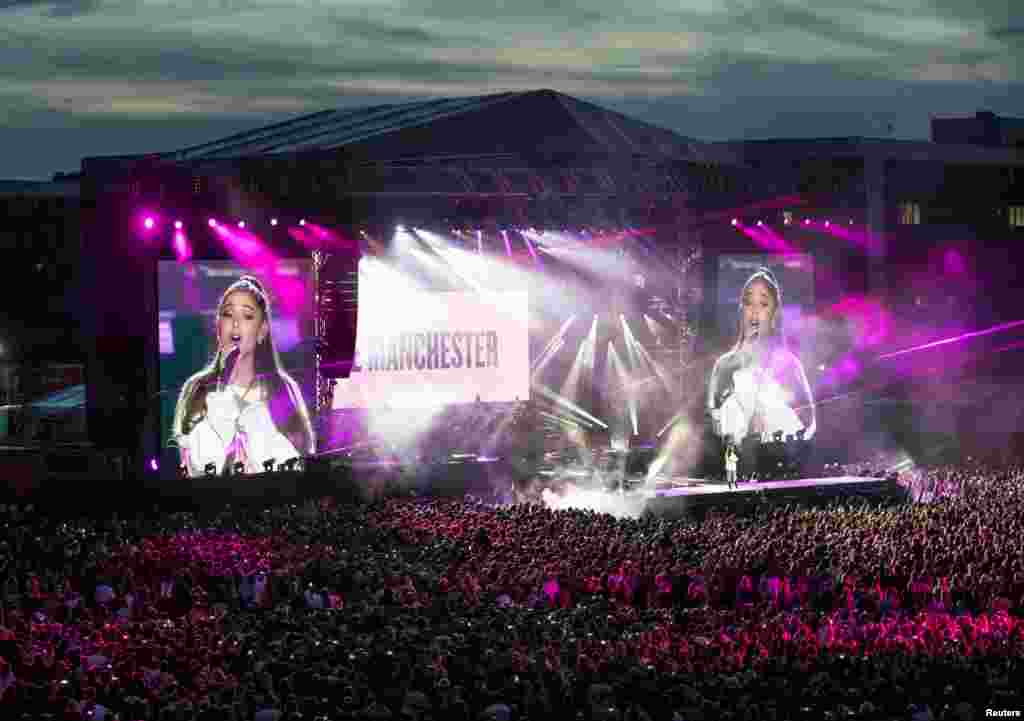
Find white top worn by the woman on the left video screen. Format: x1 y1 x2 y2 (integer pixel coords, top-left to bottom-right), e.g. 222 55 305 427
177 385 299 478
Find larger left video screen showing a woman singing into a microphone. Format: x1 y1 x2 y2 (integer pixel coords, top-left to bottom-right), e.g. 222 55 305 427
158 260 315 476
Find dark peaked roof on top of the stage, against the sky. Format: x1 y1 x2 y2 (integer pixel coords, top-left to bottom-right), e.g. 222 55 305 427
160 90 703 162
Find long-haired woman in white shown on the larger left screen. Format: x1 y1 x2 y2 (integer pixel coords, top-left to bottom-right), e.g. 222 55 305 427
171 275 313 477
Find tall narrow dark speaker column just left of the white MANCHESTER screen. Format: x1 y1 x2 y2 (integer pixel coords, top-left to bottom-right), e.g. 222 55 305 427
318 253 359 378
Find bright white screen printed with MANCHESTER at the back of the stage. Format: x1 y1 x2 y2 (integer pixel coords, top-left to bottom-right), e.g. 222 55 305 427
333 290 529 409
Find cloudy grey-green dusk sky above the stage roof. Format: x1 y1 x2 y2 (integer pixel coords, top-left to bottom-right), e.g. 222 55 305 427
0 0 1024 178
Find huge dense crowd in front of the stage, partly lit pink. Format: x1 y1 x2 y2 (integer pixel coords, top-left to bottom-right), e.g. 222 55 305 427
0 458 1024 721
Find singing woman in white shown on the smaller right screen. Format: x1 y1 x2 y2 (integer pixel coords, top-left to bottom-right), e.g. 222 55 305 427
708 268 817 444
